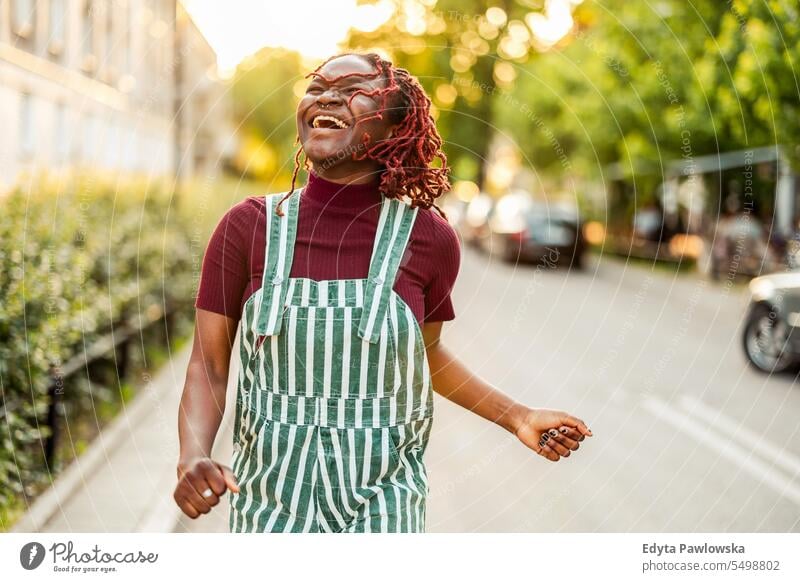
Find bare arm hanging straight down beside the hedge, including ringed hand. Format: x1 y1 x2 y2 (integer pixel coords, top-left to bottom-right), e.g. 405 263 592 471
174 309 238 518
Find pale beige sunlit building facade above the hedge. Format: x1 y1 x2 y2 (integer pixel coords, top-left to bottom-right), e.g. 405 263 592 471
0 0 227 190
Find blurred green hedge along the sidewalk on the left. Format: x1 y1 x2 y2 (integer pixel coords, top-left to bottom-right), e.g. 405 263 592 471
0 178 198 529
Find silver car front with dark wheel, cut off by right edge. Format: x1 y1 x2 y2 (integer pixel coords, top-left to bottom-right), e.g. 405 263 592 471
742 271 800 372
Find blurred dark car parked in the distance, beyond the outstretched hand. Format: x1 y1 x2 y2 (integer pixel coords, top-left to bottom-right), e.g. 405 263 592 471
486 193 586 268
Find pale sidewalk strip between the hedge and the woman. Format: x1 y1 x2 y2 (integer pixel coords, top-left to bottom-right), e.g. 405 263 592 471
12 338 238 533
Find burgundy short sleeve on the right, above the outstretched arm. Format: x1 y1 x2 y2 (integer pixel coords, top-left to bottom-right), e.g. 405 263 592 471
423 214 461 323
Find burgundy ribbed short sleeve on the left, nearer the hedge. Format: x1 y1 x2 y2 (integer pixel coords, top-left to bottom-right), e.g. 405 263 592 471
195 200 257 321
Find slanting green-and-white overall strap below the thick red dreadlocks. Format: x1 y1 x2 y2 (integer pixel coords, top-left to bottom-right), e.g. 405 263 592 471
358 198 418 343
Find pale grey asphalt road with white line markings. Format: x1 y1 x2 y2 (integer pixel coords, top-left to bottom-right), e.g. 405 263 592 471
176 248 800 532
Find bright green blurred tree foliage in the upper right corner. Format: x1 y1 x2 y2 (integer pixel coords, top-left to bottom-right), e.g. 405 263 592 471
496 0 800 184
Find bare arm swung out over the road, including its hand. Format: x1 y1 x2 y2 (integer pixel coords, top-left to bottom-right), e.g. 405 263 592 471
422 321 592 461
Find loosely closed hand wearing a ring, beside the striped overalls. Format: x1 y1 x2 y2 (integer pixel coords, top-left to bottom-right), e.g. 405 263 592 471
172 457 239 519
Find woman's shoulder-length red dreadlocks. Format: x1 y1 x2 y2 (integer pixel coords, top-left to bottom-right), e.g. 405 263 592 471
276 53 450 219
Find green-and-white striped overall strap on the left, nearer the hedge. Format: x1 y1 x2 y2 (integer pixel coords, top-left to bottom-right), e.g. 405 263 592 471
256 191 301 336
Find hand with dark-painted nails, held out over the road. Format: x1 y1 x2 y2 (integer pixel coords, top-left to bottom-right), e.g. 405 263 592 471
514 408 592 462
